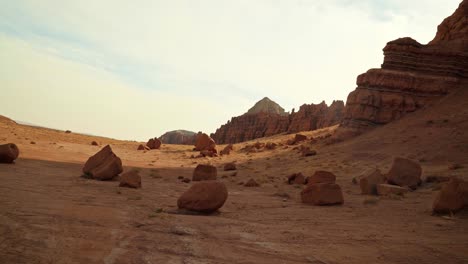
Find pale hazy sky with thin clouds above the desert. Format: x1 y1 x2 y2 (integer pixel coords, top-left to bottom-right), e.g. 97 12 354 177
0 0 461 140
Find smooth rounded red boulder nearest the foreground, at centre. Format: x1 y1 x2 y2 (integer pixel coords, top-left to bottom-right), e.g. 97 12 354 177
177 181 228 213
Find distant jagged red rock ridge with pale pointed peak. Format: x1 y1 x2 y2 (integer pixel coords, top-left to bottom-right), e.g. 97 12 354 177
211 97 344 144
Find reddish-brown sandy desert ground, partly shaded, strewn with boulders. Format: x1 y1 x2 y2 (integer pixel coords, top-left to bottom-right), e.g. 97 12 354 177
0 89 468 264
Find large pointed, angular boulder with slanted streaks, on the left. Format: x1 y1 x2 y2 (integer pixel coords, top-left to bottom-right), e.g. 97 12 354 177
83 145 123 180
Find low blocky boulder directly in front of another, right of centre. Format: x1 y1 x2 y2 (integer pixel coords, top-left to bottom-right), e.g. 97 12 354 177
301 183 344 205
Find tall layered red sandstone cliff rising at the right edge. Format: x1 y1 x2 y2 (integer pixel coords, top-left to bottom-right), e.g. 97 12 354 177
340 0 468 132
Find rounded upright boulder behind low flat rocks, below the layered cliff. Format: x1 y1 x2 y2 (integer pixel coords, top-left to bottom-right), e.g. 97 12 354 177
387 157 422 189
